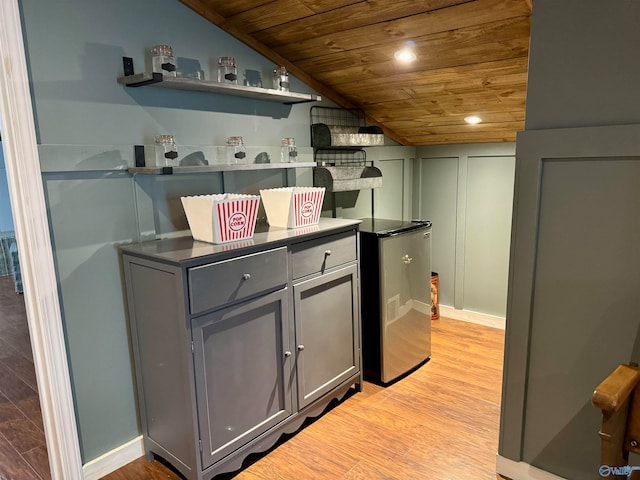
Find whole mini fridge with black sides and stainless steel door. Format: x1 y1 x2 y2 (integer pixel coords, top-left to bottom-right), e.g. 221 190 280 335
360 218 431 384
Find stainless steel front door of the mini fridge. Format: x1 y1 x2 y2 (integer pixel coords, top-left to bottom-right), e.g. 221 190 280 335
378 227 431 383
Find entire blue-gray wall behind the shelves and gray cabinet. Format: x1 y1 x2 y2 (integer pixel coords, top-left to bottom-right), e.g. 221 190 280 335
21 0 324 463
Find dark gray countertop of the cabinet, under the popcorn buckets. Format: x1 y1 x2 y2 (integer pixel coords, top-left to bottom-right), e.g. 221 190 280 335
120 217 361 267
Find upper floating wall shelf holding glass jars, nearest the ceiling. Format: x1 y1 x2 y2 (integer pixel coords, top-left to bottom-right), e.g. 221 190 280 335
118 72 322 105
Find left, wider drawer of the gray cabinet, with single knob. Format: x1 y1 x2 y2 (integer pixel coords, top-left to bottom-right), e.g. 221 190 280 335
187 247 287 314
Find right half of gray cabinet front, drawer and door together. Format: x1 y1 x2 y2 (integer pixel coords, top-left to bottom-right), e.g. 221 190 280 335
290 232 361 408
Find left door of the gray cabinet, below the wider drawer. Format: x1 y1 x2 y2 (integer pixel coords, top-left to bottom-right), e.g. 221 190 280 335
192 289 291 468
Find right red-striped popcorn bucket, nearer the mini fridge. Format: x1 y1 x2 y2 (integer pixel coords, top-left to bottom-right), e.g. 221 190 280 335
260 187 325 228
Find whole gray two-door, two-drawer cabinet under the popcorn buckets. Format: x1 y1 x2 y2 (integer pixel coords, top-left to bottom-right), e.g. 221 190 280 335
121 219 362 480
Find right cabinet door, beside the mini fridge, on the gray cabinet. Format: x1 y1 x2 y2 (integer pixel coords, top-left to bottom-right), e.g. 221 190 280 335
293 264 360 408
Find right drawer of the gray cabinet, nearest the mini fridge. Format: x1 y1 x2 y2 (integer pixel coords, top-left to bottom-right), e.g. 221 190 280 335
291 232 357 278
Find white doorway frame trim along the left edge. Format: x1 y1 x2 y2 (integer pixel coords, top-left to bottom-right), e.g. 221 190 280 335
0 0 83 480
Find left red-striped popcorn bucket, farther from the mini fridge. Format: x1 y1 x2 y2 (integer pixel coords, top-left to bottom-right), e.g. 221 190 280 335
180 193 260 243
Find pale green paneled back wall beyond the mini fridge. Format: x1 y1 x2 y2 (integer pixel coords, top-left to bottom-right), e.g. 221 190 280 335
414 143 515 317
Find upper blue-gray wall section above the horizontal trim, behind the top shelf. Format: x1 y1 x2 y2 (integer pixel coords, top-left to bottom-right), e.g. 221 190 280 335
21 0 318 146
